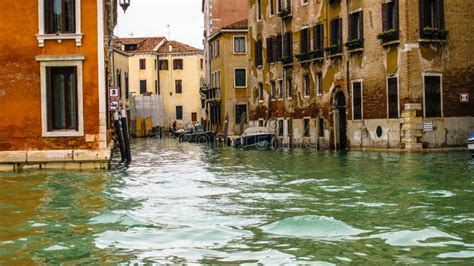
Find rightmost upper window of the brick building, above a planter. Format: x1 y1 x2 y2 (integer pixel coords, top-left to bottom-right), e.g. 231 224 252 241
420 0 444 32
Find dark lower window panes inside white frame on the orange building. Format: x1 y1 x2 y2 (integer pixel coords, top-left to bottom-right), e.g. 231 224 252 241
46 67 78 131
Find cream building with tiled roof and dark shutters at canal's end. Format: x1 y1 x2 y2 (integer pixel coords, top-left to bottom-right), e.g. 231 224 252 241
113 37 204 128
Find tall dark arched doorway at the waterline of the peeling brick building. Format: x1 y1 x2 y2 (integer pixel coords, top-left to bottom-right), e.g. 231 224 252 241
333 88 347 151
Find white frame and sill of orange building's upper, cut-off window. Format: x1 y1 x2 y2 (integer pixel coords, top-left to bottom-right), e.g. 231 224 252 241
36 0 84 47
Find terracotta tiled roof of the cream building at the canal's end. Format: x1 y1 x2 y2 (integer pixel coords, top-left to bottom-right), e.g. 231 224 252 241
113 37 203 53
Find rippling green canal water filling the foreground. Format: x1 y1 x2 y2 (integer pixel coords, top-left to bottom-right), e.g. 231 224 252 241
0 140 474 265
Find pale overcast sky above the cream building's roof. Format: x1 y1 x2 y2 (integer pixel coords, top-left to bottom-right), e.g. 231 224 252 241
115 0 204 48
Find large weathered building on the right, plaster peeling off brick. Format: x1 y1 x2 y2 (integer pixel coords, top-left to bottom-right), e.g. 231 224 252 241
249 0 474 150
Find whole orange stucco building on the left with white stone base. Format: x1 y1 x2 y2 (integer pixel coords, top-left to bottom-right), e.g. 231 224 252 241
0 0 116 170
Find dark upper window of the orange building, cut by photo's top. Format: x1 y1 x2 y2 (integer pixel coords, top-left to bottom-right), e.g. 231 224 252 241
44 0 76 34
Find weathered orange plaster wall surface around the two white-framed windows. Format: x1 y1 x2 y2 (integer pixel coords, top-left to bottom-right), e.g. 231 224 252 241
0 0 99 151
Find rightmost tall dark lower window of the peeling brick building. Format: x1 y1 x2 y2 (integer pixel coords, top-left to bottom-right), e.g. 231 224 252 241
424 75 442 117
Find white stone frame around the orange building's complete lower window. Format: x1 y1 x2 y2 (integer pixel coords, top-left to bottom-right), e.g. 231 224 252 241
36 55 86 138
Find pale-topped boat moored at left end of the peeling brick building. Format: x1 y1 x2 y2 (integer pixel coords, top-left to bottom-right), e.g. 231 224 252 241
235 127 276 148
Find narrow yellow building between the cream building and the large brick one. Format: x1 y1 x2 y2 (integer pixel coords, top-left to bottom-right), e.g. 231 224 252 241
206 19 249 135
